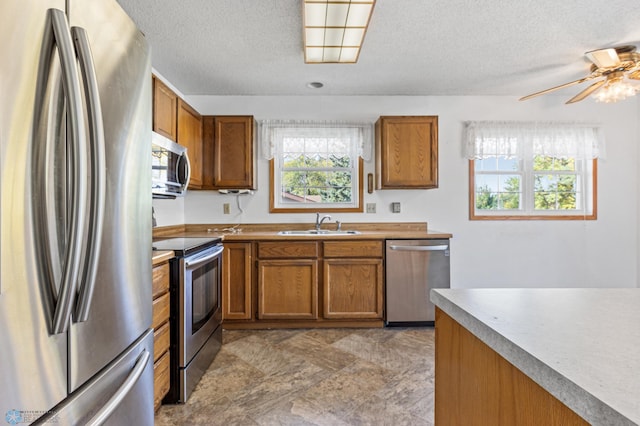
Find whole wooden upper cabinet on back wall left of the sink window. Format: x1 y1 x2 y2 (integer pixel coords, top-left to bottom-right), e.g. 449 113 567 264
203 116 256 189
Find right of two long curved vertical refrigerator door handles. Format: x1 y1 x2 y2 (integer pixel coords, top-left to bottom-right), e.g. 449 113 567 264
71 27 106 322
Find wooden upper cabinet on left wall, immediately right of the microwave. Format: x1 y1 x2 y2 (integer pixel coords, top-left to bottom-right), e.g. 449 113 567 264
178 98 202 189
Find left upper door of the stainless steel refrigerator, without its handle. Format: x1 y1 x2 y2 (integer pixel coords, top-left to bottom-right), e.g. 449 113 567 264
0 0 67 422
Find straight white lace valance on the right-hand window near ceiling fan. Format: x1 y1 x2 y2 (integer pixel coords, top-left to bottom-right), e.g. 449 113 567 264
464 121 605 160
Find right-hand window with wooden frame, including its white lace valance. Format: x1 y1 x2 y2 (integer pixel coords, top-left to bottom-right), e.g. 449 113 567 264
466 122 604 220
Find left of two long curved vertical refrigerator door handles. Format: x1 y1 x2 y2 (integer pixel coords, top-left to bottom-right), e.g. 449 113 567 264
34 9 86 334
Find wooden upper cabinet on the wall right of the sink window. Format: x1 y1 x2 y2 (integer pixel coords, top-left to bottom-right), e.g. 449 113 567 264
376 116 438 189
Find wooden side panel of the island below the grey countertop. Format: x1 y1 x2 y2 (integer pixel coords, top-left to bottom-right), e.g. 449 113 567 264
435 308 588 426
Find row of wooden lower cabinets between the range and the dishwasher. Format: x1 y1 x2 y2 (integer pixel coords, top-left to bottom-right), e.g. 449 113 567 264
223 240 384 328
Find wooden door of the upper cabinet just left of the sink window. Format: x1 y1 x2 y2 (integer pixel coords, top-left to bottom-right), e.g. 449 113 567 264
213 116 255 189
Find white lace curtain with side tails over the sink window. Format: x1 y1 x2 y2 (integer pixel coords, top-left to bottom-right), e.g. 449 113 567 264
258 120 373 161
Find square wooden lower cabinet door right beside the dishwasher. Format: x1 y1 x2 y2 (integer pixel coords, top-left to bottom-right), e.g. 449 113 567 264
323 259 383 319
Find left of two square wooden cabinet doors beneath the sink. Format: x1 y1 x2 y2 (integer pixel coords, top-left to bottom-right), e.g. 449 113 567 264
258 259 318 319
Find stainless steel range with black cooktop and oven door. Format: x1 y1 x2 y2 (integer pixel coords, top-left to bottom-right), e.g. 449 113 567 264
153 238 222 403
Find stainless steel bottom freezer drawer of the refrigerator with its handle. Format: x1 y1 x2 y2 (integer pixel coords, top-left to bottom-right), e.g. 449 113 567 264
35 330 153 426
